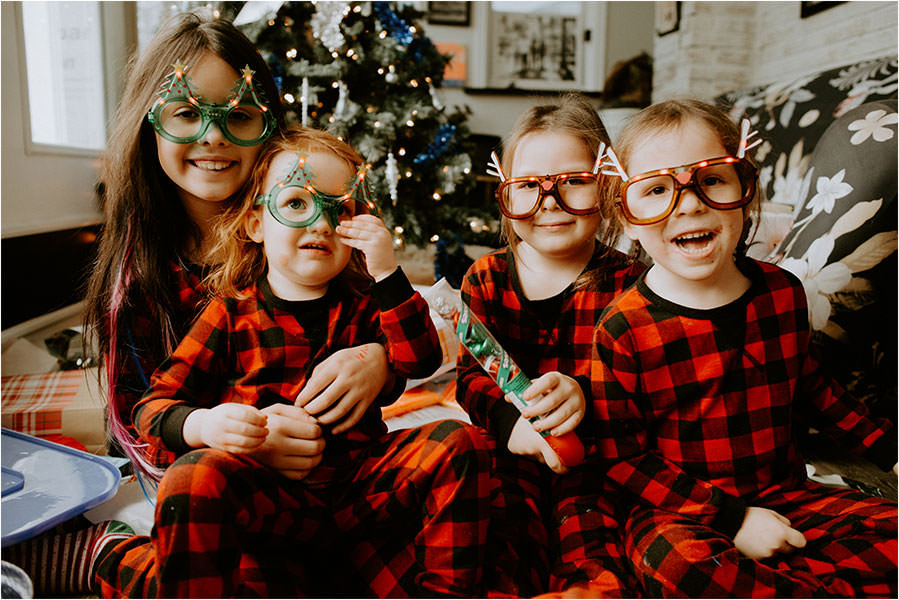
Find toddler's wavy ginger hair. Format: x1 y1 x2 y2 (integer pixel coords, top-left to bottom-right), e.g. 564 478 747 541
206 126 371 298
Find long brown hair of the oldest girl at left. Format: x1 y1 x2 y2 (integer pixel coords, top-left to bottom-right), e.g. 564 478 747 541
84 13 283 480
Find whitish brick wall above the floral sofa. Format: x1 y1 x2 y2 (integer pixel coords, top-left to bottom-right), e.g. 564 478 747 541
653 1 899 101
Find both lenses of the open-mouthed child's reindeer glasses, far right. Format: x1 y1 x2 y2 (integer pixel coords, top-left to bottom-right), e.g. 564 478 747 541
624 164 747 220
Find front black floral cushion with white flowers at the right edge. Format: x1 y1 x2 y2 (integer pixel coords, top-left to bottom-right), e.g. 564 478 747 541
769 100 899 410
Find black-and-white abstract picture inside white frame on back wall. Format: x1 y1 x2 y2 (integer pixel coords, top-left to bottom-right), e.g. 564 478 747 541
487 11 584 90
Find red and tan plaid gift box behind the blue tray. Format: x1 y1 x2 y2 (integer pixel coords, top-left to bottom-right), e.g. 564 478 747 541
0 368 105 452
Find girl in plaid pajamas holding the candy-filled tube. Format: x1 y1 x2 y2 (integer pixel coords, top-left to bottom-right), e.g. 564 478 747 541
456 94 643 597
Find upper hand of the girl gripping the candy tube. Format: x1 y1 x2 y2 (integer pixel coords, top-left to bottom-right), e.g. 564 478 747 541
521 371 587 436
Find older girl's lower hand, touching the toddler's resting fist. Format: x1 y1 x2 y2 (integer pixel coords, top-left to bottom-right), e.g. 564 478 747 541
252 404 325 480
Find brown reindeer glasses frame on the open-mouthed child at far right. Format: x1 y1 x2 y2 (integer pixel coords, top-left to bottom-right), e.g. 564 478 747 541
615 156 758 225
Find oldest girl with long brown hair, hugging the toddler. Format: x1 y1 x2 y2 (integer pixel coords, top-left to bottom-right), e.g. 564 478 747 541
4 13 404 594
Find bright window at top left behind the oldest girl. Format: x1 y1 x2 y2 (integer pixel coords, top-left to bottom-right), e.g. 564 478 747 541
22 2 106 151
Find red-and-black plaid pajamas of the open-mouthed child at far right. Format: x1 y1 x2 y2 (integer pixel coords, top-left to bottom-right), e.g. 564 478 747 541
592 259 897 598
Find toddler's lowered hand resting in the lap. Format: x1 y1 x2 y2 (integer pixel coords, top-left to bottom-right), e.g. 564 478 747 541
182 402 268 454
